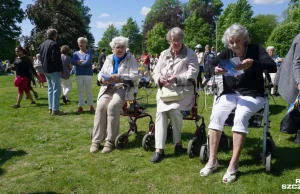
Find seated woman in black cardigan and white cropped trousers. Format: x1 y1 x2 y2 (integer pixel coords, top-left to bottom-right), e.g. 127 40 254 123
200 24 277 183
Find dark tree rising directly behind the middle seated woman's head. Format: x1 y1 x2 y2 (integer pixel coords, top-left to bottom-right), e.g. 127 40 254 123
143 0 184 36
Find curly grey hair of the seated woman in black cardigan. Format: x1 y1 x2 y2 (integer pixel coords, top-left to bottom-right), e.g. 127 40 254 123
222 23 249 47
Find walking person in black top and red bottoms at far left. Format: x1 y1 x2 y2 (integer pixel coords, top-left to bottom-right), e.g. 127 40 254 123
12 46 38 108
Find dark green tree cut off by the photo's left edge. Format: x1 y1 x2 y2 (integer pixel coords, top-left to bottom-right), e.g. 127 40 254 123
0 0 24 61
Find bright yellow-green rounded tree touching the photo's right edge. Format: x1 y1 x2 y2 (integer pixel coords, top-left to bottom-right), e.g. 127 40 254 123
266 22 300 57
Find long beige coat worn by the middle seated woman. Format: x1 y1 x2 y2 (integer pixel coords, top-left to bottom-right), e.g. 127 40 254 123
153 46 199 112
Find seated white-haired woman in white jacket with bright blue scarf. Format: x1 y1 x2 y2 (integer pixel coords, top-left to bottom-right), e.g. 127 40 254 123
90 36 138 153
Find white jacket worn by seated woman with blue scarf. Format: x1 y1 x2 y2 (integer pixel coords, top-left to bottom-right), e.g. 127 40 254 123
97 54 138 100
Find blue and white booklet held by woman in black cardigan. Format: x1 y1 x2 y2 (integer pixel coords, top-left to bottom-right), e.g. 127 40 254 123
219 57 244 76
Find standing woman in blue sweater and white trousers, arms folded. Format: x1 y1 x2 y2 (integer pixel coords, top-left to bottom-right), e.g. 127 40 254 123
72 37 95 113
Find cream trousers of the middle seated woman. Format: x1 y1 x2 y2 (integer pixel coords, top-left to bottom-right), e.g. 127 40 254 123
155 109 183 149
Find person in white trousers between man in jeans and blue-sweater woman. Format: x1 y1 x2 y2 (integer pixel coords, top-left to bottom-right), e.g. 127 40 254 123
60 45 73 104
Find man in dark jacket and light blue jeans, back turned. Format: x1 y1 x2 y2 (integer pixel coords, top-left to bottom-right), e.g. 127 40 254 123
39 29 64 115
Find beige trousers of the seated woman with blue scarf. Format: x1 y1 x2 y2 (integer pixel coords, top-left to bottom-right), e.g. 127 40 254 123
92 87 125 144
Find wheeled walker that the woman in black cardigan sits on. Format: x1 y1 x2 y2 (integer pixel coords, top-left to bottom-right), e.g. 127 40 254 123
200 73 276 172
